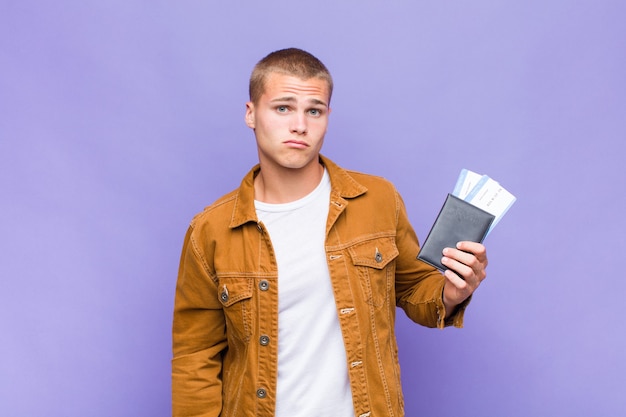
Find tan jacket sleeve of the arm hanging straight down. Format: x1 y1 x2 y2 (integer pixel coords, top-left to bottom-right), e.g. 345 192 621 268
172 227 227 417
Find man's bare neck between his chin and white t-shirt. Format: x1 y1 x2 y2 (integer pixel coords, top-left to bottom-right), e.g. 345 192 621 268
254 159 324 204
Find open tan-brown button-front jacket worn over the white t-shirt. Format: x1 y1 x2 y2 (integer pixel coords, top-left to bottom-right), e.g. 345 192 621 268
172 157 465 417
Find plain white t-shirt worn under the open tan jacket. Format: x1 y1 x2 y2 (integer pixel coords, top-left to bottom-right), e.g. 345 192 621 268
255 170 354 417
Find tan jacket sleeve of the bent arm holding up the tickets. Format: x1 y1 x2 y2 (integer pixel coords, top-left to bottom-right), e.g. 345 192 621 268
396 189 469 328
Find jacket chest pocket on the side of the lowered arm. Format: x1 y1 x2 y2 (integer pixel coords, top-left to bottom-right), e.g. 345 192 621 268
217 278 253 341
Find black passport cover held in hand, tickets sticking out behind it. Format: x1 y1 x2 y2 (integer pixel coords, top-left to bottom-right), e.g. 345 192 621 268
417 194 495 271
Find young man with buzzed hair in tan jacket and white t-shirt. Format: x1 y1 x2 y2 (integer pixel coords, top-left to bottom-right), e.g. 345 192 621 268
172 49 487 417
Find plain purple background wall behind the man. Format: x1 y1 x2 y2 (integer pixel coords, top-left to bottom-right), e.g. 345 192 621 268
0 0 626 417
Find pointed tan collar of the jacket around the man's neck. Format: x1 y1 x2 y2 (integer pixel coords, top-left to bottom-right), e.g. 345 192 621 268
229 155 367 228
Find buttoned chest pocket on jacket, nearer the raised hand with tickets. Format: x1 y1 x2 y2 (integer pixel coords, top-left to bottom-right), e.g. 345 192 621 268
348 237 399 308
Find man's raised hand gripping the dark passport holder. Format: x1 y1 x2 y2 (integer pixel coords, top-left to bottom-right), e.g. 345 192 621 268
441 242 487 316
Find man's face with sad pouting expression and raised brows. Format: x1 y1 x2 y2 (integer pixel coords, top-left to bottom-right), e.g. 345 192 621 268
246 73 330 170
